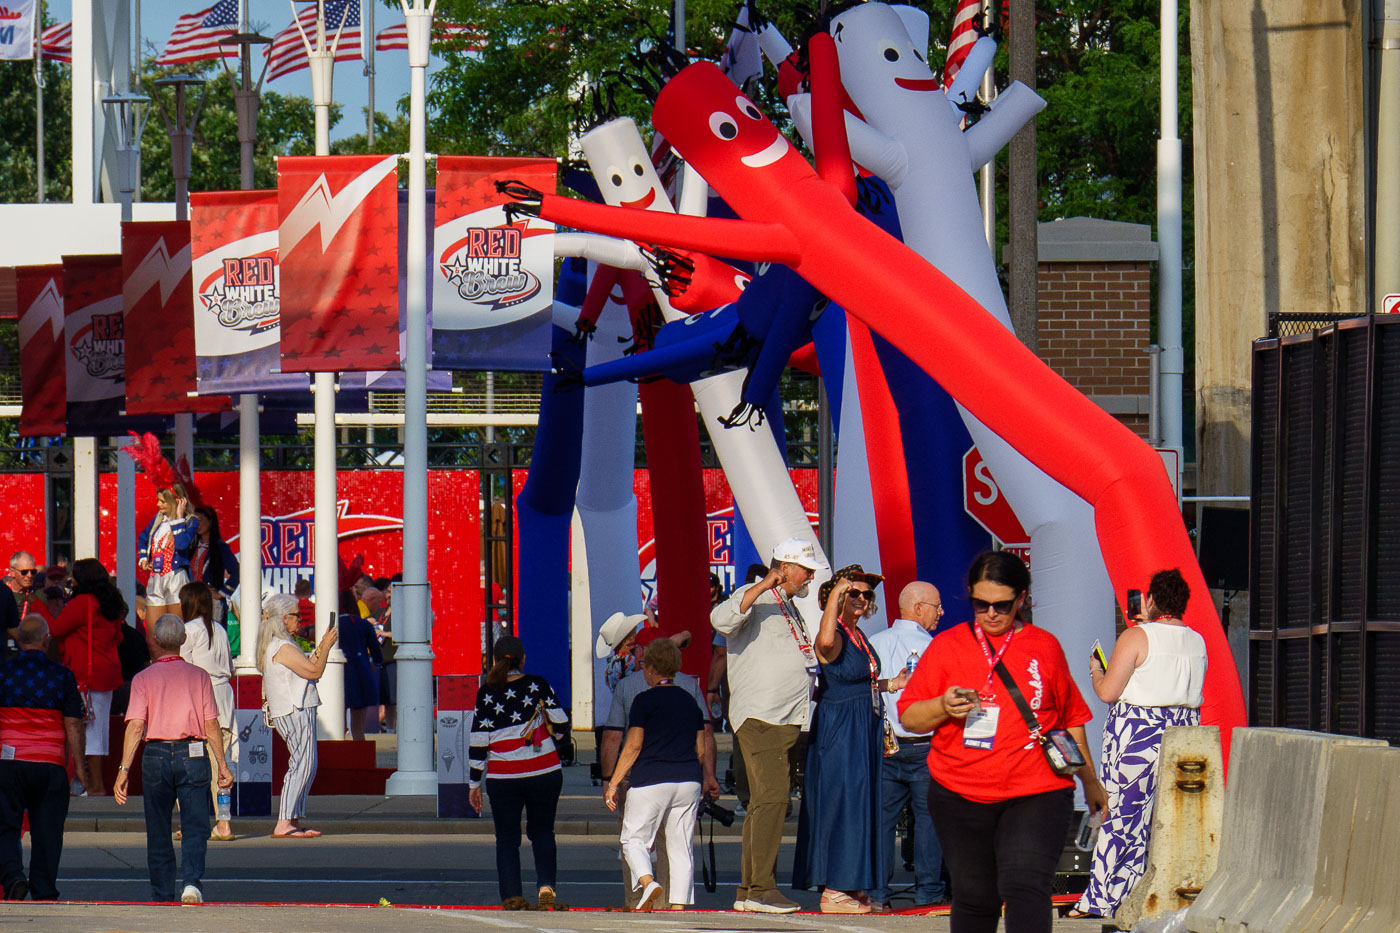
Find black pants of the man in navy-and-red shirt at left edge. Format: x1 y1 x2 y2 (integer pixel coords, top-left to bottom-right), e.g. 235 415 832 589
0 761 69 901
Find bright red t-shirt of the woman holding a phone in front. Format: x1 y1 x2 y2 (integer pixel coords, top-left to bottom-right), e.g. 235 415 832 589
899 625 1093 803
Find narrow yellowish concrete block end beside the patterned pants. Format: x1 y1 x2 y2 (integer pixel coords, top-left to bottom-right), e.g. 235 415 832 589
1113 726 1225 930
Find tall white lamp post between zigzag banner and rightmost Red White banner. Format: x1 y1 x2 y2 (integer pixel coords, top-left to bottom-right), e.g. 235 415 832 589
385 0 437 796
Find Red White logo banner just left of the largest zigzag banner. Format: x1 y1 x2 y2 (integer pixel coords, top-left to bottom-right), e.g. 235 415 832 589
189 191 311 395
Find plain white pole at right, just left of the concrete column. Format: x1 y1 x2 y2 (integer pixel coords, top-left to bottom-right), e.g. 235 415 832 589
1156 0 1186 450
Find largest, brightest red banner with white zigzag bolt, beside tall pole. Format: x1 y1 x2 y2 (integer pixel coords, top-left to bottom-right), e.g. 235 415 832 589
277 156 399 373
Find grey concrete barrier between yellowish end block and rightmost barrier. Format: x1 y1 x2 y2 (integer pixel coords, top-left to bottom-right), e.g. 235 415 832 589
1186 728 1386 933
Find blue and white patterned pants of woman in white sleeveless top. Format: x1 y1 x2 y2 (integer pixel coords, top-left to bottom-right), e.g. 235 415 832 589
1075 703 1201 918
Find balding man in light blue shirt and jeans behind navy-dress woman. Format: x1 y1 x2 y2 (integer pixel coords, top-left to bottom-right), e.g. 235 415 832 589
869 580 949 913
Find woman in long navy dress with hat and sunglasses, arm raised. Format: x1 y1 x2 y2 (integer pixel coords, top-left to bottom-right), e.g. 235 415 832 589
792 563 909 913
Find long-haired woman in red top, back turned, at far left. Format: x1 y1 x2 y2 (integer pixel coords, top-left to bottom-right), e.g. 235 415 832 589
49 558 126 797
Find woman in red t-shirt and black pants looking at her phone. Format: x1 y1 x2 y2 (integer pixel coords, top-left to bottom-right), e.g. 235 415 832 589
899 551 1107 933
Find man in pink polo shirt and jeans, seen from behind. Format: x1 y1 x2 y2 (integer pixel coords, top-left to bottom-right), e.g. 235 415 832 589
113 612 234 904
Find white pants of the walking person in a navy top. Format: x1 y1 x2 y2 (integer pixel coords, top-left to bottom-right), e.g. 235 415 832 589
622 780 700 904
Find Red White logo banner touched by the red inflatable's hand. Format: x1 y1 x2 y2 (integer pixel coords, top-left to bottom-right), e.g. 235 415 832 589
431 156 556 371
